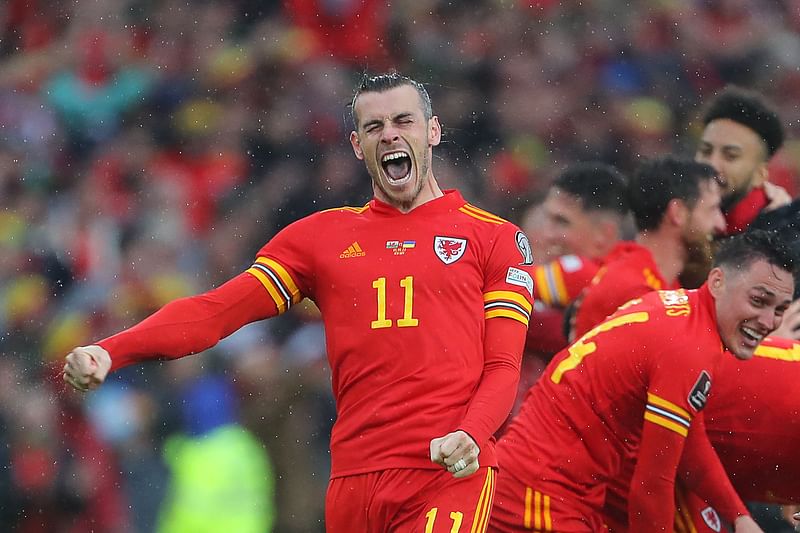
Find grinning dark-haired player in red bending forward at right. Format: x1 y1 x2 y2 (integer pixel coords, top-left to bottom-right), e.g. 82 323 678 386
490 232 795 532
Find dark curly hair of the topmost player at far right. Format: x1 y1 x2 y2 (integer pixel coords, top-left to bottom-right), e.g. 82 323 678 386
703 85 784 157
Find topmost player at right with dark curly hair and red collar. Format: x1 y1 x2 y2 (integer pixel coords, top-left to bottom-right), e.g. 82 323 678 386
695 86 790 235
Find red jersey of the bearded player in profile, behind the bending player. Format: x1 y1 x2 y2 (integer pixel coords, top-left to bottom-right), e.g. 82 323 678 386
575 241 679 337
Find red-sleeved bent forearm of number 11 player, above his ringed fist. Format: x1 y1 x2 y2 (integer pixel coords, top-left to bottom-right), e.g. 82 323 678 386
458 318 527 447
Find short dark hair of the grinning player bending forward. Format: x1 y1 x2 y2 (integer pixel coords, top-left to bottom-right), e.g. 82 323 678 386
713 229 797 276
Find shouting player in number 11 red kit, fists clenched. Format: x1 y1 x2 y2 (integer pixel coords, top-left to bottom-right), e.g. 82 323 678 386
64 74 533 533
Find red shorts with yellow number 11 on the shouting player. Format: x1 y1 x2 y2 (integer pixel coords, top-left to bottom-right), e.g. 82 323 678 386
325 467 497 533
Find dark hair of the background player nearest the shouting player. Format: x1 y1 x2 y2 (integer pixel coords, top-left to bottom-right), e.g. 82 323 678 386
552 161 629 217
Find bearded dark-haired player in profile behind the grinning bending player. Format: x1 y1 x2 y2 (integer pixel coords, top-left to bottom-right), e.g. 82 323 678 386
575 155 724 336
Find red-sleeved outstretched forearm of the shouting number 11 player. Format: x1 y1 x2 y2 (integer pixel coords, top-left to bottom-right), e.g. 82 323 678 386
97 274 277 371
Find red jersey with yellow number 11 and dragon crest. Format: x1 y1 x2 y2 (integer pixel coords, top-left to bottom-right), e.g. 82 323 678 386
248 191 533 477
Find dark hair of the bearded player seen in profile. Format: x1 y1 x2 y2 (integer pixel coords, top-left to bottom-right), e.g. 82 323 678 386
628 155 717 231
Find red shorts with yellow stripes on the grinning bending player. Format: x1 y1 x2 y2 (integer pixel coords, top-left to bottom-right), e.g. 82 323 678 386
488 470 606 533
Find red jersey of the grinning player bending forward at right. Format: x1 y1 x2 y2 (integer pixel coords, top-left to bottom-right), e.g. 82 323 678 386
496 286 723 531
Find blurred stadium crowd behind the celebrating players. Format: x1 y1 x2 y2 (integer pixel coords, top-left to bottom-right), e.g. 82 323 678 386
0 0 800 532
